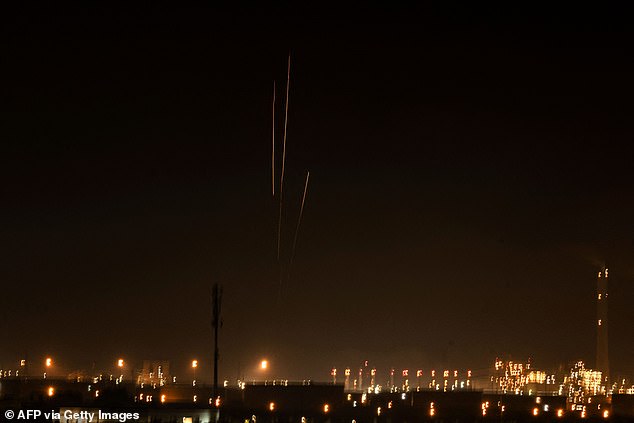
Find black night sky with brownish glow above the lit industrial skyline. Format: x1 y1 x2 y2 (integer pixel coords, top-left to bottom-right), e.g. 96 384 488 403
0 3 634 380
